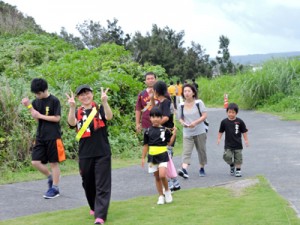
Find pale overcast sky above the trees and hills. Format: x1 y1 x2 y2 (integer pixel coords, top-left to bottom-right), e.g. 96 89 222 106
3 0 300 57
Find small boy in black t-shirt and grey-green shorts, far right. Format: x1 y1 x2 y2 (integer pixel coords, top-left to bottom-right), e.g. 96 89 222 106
217 103 249 177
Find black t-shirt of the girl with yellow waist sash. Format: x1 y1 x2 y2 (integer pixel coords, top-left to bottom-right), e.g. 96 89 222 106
144 126 172 164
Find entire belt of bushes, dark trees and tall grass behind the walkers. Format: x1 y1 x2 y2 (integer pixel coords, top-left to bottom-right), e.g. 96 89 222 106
0 1 300 174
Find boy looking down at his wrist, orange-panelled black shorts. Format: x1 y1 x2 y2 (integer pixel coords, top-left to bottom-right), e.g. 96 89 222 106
22 78 66 199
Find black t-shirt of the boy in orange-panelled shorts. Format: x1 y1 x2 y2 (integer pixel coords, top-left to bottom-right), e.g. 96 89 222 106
32 94 61 140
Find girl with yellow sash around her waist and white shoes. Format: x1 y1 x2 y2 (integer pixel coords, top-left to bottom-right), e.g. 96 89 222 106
142 106 176 205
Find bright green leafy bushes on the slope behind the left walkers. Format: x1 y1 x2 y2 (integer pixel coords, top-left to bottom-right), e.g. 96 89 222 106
0 33 166 168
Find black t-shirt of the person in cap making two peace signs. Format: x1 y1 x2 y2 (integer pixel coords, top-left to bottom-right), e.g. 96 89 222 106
75 106 111 159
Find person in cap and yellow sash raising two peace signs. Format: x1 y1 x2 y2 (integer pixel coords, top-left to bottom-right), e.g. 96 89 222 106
67 84 113 224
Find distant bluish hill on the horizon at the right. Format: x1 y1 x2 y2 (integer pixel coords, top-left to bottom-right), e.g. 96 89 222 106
231 52 300 65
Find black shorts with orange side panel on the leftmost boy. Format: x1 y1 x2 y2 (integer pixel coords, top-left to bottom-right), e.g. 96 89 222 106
31 139 66 164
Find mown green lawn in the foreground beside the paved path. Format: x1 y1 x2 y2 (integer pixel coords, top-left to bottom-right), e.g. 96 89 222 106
0 177 300 225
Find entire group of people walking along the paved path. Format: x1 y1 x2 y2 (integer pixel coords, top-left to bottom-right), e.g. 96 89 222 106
22 72 248 224
